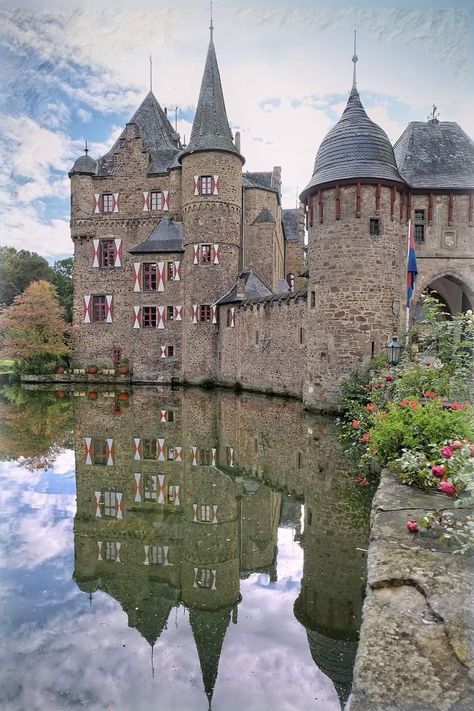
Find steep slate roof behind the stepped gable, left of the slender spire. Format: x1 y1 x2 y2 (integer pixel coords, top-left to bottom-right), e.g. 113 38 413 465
97 91 181 175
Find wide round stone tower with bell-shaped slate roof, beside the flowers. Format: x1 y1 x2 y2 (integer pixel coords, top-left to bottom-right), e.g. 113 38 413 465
301 55 407 408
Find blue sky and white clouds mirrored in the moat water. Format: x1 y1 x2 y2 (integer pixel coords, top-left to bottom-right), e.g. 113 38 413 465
0 451 339 711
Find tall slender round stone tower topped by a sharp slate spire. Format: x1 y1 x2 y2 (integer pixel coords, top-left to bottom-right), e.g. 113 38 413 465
180 30 244 383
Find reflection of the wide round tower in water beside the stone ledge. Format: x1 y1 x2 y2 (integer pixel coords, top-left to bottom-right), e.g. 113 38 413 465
294 428 368 708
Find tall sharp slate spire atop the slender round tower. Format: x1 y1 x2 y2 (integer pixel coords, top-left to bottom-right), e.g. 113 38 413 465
180 35 244 162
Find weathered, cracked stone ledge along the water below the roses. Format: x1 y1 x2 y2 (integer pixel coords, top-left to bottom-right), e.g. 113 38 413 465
349 470 474 711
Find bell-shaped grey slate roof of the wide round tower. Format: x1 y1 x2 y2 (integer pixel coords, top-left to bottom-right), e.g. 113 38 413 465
302 88 403 196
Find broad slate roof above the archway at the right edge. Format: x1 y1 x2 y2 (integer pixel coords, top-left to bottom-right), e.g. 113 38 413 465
394 119 474 189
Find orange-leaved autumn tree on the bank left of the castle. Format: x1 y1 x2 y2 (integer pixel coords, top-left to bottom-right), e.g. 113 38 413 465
0 280 71 372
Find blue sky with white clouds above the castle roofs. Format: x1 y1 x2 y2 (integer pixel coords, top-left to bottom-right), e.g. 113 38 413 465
0 0 474 261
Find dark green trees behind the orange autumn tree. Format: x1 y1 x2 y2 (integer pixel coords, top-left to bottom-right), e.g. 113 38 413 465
0 247 54 306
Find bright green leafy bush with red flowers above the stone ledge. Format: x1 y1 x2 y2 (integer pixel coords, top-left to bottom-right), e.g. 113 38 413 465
370 400 474 466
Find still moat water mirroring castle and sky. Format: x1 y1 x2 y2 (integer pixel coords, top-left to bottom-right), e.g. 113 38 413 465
0 386 373 711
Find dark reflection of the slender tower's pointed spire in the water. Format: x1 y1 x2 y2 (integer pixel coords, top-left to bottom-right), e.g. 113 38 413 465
189 608 230 708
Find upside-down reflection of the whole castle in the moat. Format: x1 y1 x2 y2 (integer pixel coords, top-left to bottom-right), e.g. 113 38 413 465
74 390 367 702
